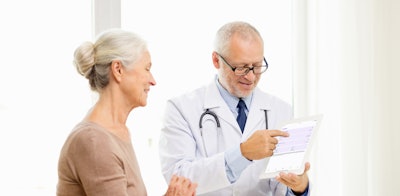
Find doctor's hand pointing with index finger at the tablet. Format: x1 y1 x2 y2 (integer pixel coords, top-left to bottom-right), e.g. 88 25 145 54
240 130 289 160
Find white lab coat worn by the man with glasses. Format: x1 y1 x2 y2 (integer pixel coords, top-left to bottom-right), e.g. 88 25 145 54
159 81 293 196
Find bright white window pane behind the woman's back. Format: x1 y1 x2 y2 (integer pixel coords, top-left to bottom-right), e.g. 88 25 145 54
0 0 92 196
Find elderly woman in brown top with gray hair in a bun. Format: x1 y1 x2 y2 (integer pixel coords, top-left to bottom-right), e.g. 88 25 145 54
57 29 197 196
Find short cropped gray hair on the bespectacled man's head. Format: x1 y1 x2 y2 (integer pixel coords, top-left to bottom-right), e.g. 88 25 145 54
214 21 263 55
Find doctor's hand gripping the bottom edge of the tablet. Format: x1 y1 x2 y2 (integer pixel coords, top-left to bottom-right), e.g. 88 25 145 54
276 162 310 193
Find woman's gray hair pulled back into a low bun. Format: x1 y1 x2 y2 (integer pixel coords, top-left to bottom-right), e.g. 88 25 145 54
73 29 148 92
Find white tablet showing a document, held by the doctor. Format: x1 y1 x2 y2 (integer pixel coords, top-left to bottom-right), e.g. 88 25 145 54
260 114 323 179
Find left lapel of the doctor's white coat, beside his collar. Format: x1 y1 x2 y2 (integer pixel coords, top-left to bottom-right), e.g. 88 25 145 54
204 81 241 133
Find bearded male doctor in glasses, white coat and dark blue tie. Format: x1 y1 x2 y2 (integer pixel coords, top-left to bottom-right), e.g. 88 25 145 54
159 22 310 196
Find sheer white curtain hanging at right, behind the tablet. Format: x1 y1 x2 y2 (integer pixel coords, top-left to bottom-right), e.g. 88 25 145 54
293 0 400 196
